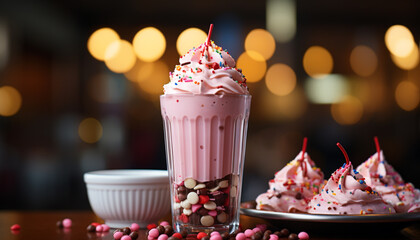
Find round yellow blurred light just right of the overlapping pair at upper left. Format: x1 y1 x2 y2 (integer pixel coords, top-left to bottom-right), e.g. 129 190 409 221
133 27 166 62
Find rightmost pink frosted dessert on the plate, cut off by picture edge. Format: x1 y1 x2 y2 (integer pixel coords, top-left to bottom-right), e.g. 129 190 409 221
357 137 420 213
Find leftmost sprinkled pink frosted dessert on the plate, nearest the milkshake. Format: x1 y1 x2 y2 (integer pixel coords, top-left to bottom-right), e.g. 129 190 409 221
256 138 324 212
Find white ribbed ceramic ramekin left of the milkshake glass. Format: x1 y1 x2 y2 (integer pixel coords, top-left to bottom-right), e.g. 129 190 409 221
84 170 170 228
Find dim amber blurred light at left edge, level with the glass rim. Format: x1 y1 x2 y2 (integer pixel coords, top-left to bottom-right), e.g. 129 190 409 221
0 86 22 117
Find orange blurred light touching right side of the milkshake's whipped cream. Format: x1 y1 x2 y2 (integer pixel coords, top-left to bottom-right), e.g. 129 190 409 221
236 51 267 82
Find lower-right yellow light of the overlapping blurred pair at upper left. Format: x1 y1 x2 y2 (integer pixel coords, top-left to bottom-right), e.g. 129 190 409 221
105 40 136 73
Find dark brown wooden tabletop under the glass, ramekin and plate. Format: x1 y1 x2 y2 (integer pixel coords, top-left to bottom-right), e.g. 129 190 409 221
0 211 420 240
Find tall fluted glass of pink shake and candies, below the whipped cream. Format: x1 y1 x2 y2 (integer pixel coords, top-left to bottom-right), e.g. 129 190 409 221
160 95 251 232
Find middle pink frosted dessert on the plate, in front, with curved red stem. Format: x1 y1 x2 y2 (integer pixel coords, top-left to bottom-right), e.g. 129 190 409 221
308 143 395 215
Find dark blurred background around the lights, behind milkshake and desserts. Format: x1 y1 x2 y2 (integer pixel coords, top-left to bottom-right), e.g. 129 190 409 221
0 0 420 210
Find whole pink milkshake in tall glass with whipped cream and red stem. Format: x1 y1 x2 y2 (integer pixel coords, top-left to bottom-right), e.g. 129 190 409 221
160 26 251 233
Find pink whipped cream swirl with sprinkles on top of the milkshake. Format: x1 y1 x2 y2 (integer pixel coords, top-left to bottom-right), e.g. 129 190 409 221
163 41 249 95
